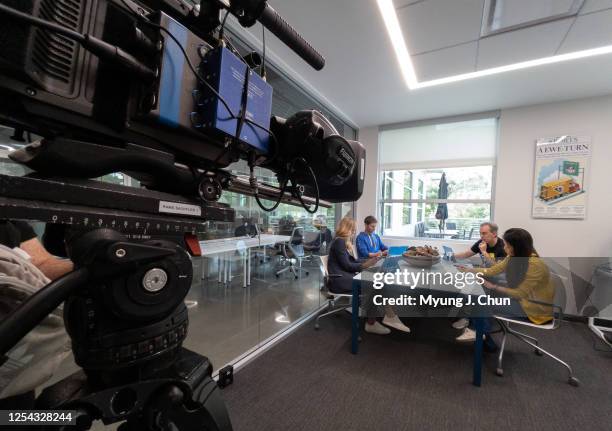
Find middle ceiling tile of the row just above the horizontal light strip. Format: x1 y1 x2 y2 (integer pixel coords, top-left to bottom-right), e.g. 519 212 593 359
478 18 575 70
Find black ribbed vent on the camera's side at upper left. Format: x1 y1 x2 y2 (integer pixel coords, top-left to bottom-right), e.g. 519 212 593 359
32 0 82 85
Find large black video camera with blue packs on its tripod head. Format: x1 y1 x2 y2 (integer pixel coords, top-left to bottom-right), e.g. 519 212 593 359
0 0 365 430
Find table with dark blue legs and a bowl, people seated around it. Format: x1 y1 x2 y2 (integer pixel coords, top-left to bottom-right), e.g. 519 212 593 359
351 256 486 386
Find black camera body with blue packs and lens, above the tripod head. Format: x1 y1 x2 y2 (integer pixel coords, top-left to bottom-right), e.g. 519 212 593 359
0 0 365 202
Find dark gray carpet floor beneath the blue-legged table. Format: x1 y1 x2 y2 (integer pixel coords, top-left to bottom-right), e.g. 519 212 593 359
222 314 612 431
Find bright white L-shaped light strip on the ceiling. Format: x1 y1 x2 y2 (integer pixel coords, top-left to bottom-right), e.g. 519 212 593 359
377 0 612 90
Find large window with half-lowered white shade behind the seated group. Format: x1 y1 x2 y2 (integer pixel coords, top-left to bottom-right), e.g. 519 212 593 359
379 119 497 239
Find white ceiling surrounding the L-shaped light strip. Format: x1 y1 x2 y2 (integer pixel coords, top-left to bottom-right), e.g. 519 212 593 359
227 0 612 127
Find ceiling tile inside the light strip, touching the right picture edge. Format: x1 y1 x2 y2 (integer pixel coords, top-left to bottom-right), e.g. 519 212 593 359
558 10 612 54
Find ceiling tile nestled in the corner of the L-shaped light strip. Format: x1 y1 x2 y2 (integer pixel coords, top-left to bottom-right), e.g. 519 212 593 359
412 42 478 82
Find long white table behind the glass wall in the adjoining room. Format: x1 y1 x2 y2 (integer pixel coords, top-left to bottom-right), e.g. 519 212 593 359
200 234 291 287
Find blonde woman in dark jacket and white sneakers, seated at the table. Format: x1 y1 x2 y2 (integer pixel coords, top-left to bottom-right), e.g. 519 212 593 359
327 217 410 335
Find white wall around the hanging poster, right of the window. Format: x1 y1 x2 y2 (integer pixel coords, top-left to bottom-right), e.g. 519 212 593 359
495 96 612 257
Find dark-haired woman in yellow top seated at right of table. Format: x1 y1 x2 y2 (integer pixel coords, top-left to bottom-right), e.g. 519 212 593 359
457 228 555 341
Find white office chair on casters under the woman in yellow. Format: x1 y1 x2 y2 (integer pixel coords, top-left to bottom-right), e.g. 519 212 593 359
493 272 580 386
